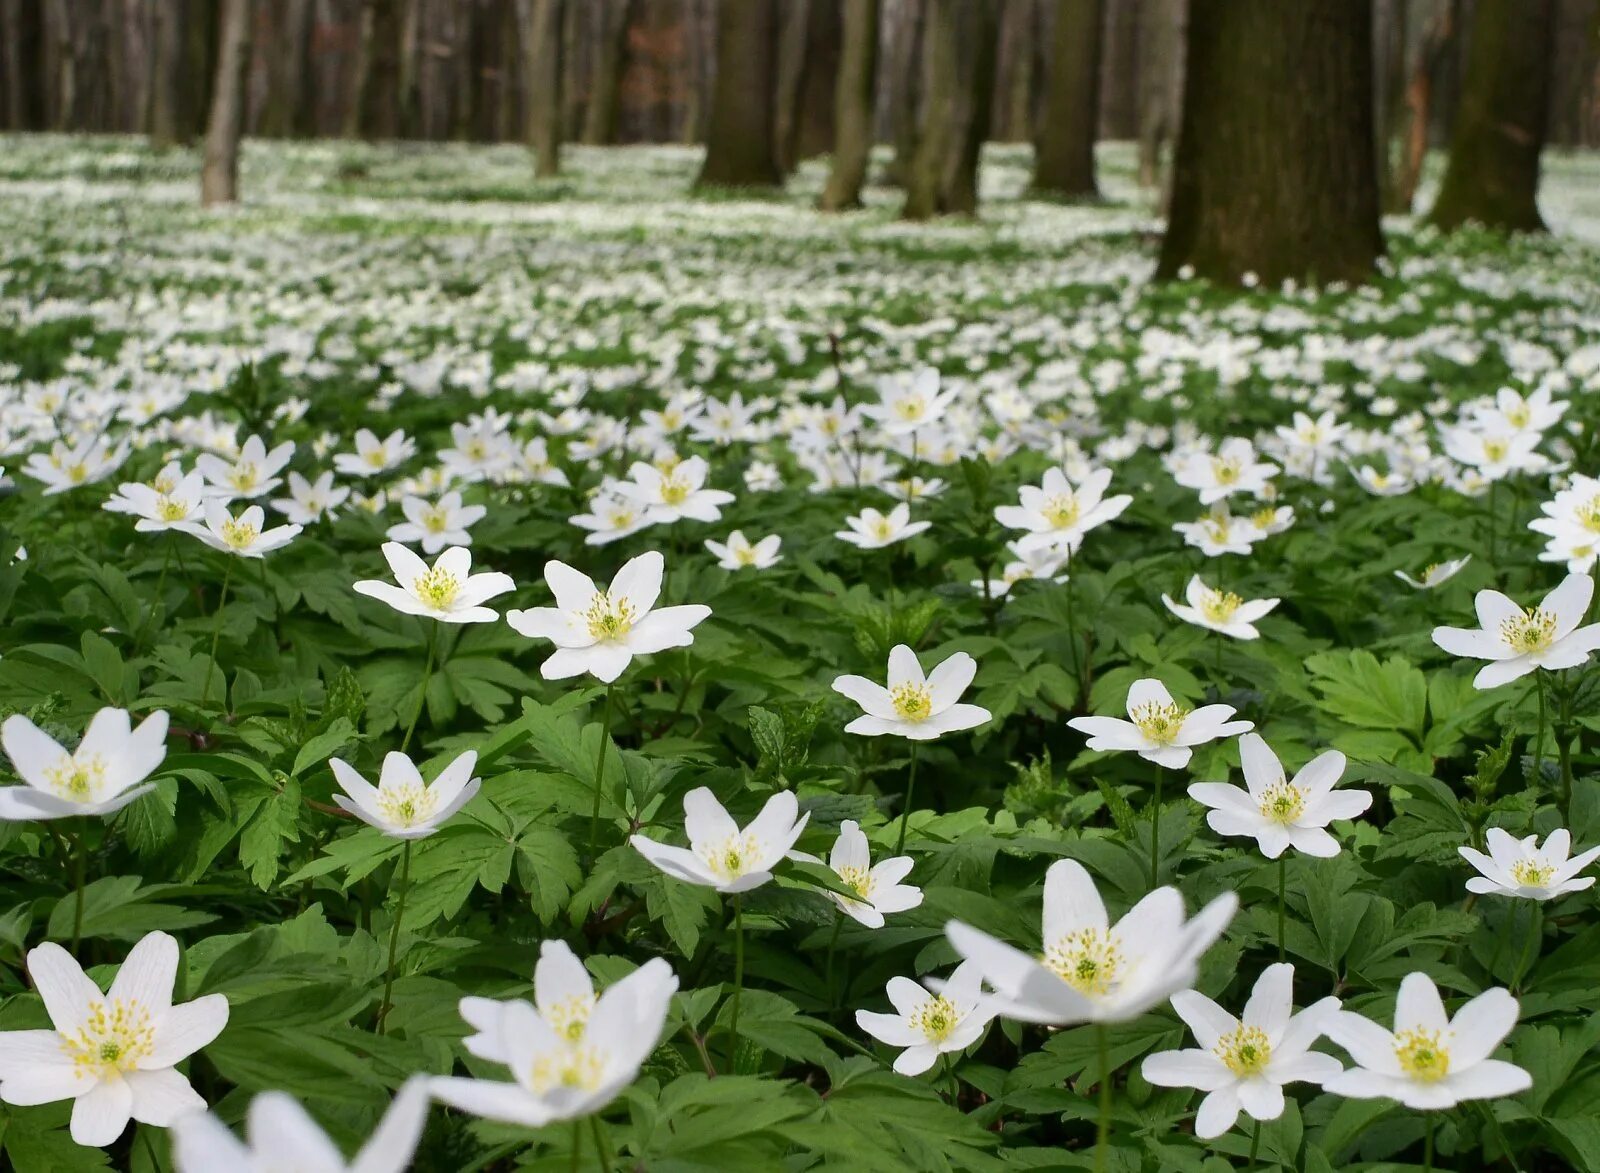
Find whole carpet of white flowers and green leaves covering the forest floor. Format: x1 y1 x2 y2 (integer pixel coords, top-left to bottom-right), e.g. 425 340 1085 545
0 138 1600 1173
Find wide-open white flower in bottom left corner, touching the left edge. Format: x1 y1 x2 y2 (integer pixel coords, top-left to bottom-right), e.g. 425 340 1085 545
0 933 227 1147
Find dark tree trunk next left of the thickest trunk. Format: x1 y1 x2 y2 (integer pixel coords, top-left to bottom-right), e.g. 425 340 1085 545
1034 0 1106 200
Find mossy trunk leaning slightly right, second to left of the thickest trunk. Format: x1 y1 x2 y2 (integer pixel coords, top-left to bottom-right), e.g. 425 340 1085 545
901 0 1000 219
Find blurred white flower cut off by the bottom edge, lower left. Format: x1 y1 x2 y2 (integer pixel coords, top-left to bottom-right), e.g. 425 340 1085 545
173 1075 429 1173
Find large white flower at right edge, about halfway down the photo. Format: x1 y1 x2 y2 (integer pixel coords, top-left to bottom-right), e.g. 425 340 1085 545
1434 574 1600 688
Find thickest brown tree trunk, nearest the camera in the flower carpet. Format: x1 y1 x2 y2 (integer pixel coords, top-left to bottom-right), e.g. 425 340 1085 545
1157 0 1384 285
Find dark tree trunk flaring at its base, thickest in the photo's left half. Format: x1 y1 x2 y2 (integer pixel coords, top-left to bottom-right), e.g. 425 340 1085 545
696 0 784 187
